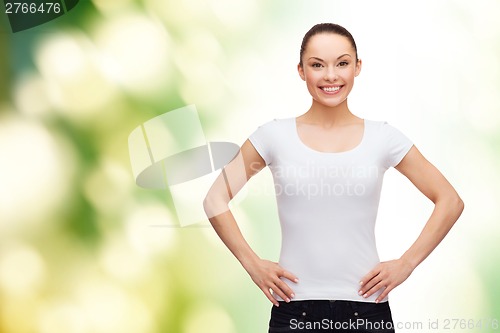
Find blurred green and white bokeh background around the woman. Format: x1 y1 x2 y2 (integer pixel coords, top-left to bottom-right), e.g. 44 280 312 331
0 0 500 333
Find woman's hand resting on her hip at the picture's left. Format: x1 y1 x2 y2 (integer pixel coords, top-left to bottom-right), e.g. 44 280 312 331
245 259 299 306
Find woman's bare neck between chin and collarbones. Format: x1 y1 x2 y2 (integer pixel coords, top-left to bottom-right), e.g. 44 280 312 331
302 99 358 127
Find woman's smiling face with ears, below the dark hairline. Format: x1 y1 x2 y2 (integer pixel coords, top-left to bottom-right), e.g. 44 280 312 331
298 33 361 107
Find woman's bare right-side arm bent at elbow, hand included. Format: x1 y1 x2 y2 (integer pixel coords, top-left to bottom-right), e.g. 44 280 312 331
359 146 464 303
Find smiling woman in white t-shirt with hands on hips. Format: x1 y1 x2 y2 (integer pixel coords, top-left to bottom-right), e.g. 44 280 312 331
204 23 463 332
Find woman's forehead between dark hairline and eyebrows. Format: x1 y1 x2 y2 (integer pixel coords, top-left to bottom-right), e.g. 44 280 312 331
305 33 355 56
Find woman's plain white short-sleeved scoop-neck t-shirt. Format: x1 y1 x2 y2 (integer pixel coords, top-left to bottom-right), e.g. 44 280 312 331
249 118 413 302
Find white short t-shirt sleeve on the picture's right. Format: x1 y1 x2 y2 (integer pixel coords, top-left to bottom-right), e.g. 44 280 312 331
382 122 413 168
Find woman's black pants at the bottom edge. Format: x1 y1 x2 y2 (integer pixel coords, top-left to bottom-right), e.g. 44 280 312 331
269 300 394 333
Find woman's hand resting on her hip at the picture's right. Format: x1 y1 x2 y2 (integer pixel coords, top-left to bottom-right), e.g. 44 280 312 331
359 259 413 303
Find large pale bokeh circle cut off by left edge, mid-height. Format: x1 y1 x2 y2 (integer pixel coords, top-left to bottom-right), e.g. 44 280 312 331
0 118 74 231
